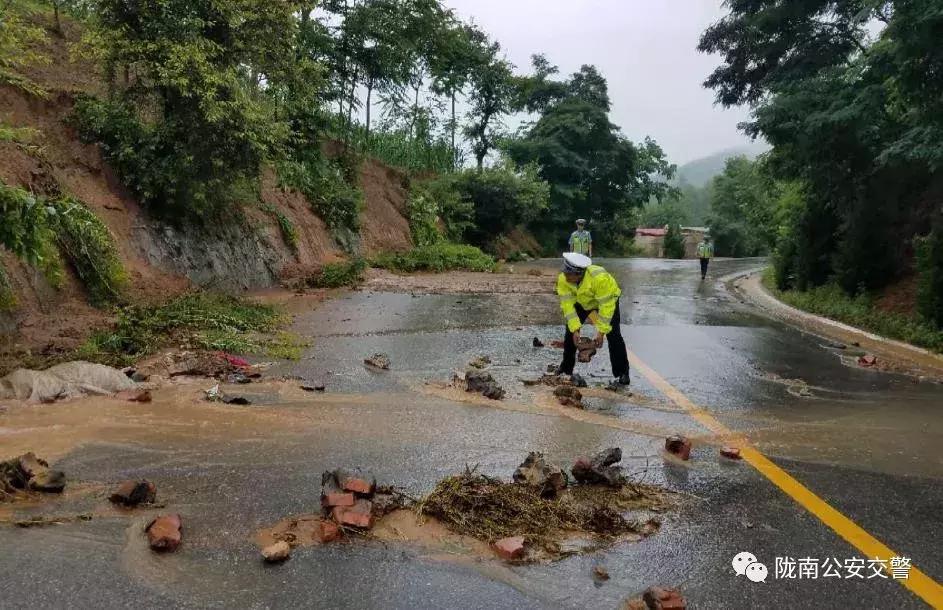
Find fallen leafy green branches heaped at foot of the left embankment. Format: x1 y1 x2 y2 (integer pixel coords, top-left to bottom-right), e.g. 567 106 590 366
72 292 303 366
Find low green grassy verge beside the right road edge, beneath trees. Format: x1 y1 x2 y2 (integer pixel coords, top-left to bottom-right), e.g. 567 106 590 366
763 268 943 352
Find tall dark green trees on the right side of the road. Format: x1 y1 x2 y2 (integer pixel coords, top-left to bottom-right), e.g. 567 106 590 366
700 0 943 304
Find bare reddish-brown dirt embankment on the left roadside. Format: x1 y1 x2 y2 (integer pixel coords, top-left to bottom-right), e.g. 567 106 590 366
0 13 411 349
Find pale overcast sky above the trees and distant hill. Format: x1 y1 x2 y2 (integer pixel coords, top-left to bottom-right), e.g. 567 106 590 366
445 0 749 165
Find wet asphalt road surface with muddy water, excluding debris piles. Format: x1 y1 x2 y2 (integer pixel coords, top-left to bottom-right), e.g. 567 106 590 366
0 259 943 608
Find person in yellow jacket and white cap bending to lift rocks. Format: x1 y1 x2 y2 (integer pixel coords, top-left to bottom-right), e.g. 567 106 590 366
557 252 630 385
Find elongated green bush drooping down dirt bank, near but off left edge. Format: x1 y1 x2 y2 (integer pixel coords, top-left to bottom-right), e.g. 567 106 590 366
50 199 127 306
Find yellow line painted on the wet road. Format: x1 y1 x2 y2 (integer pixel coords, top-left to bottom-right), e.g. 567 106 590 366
629 351 943 608
